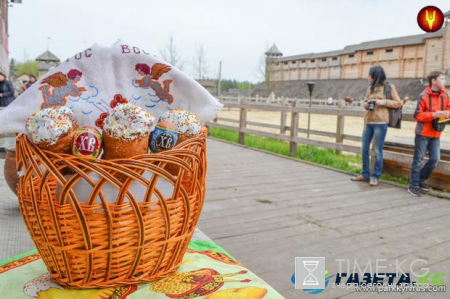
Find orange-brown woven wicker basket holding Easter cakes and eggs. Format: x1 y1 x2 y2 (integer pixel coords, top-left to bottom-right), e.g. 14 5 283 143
16 135 206 288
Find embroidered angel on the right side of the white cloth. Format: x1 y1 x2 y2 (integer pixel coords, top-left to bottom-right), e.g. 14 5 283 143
135 63 173 104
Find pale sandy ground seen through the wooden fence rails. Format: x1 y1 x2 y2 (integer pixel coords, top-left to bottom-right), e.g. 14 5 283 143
214 108 450 149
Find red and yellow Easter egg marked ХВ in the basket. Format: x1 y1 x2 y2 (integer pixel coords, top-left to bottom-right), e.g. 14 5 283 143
72 126 102 158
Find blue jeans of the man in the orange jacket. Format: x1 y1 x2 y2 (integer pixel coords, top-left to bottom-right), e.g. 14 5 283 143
409 135 441 188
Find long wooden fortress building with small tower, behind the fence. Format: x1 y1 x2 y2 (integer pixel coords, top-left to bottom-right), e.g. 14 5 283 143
266 11 450 84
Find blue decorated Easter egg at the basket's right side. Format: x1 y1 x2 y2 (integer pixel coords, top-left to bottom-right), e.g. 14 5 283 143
150 121 178 153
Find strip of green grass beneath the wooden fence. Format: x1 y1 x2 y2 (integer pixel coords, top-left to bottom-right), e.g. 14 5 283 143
209 127 409 185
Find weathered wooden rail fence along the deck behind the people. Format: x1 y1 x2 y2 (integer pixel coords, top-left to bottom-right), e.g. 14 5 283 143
208 97 450 189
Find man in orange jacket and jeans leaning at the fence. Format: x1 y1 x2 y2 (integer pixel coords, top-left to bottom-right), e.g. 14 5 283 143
408 72 450 196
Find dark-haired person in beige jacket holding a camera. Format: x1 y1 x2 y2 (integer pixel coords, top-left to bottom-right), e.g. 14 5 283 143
352 66 402 186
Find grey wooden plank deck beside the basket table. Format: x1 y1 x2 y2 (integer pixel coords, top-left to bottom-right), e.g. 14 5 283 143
0 139 450 299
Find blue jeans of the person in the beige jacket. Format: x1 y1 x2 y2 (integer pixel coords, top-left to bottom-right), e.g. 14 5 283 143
362 124 387 179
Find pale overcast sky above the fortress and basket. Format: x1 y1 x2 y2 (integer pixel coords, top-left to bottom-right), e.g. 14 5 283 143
9 0 450 82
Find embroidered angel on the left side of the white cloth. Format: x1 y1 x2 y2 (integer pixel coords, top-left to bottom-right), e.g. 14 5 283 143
39 69 86 108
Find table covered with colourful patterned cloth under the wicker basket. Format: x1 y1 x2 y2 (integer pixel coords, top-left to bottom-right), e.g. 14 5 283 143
0 236 283 299
